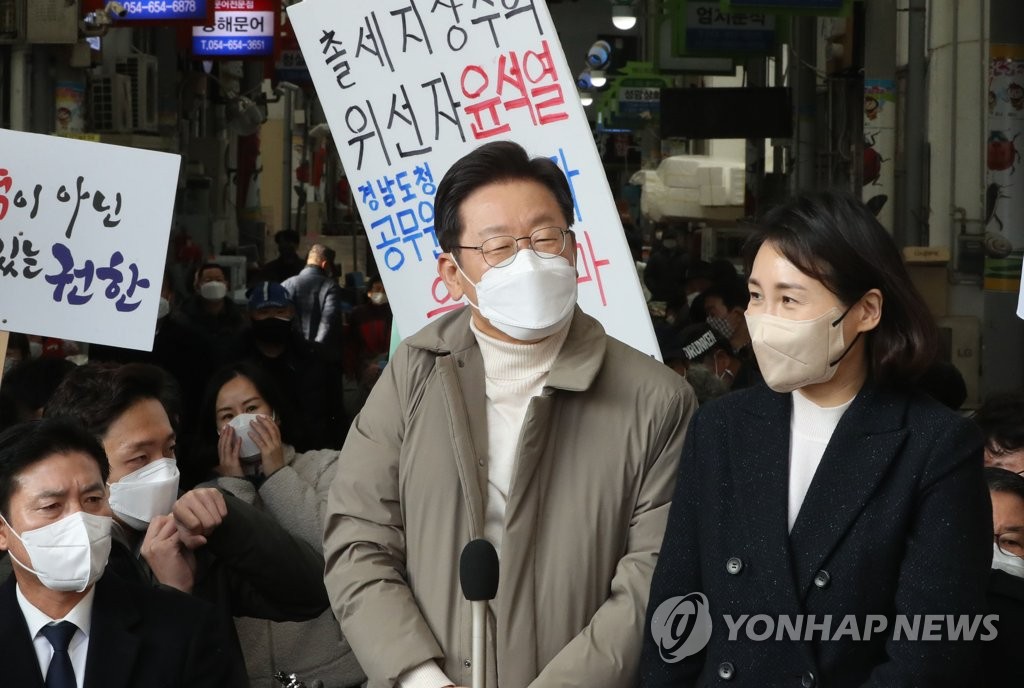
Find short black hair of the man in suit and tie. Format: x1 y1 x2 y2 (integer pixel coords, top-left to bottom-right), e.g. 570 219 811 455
0 419 111 518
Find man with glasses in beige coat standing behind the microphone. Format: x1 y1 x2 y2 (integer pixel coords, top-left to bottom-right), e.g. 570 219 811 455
325 142 696 688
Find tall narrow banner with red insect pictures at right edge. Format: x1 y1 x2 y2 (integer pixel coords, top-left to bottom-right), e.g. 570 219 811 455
985 44 1024 292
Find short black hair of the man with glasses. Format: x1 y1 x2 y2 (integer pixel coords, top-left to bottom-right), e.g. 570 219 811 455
434 141 574 253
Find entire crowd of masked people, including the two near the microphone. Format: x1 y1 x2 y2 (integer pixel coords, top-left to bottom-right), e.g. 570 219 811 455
0 142 1024 688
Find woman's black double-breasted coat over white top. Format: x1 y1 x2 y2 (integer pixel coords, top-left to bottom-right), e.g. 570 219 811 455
641 385 992 688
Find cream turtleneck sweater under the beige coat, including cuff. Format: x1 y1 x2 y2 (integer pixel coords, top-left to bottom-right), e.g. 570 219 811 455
397 318 571 688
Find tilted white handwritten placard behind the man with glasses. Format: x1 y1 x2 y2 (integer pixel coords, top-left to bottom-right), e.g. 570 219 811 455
288 0 660 358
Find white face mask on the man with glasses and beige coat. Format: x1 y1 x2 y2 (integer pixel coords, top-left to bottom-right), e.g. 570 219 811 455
456 249 577 342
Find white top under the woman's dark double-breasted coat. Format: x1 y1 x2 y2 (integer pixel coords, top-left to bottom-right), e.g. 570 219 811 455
788 389 853 532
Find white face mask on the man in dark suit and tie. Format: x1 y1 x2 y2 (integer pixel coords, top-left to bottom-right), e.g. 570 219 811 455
0 511 113 593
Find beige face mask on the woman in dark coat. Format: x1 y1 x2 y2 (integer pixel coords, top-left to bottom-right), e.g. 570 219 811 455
746 306 859 393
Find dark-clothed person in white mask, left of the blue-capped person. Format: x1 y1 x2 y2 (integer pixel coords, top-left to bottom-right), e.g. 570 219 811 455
171 263 248 361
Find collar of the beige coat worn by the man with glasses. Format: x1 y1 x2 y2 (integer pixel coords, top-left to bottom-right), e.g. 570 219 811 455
406 306 607 392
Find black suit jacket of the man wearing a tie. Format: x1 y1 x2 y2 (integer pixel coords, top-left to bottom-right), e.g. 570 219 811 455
0 571 235 688
